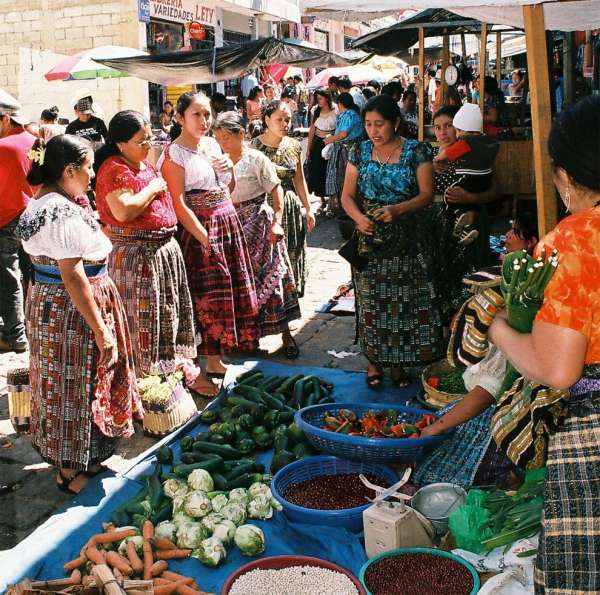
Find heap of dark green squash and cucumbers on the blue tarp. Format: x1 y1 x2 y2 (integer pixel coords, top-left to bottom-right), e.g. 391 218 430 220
193 372 333 474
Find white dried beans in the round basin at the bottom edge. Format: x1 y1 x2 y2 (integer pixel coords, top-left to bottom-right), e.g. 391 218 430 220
229 566 358 595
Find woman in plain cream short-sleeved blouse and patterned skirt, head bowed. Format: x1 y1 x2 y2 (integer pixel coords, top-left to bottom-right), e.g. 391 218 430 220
213 112 301 349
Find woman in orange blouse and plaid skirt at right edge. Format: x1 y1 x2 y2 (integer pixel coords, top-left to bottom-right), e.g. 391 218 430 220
489 97 600 593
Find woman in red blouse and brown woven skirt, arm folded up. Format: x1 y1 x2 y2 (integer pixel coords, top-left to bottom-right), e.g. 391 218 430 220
96 110 218 396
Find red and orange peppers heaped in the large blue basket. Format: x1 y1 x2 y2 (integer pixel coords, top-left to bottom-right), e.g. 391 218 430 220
323 409 437 438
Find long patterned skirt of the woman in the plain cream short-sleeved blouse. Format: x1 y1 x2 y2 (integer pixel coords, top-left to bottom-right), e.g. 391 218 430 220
236 196 301 337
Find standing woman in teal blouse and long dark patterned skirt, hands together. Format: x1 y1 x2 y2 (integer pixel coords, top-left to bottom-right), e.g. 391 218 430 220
342 95 443 388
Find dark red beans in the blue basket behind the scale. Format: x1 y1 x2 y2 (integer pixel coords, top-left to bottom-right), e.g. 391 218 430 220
283 473 388 510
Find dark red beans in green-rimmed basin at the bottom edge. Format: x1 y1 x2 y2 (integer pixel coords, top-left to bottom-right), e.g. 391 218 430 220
365 554 473 595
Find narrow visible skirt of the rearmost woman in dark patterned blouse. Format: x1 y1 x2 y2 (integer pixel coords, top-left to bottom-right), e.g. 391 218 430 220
281 190 308 297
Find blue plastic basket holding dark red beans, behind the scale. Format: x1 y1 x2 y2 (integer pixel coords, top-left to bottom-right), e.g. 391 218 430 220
271 455 398 531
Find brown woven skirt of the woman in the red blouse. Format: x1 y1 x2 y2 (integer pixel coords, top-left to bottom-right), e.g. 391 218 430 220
108 226 196 376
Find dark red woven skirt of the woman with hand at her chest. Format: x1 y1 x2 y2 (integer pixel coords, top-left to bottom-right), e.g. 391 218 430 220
179 190 260 355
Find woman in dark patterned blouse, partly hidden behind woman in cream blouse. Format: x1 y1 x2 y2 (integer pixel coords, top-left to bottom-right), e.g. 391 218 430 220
252 101 315 318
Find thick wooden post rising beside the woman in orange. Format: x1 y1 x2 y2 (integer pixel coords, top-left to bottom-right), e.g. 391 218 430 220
523 4 557 237
